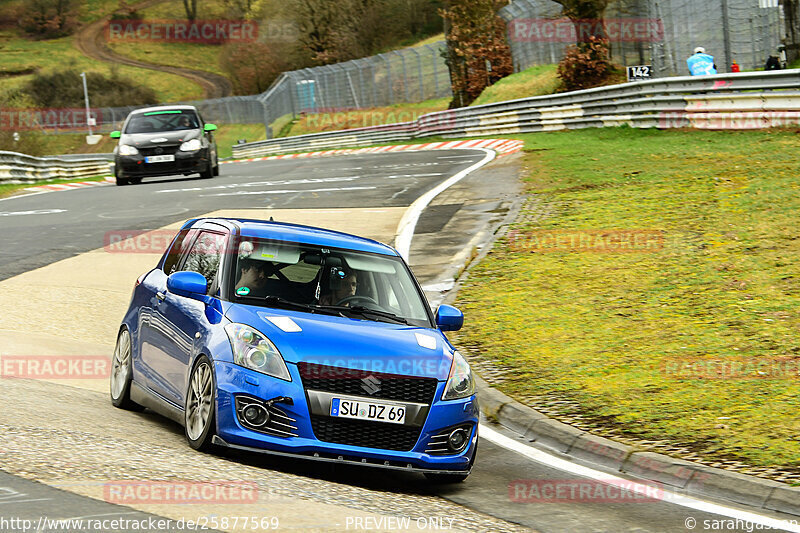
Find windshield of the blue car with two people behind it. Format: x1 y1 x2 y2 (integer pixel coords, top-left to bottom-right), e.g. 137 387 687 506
232 238 432 327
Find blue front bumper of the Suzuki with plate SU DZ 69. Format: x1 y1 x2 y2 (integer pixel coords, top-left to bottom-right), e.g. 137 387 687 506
215 362 478 474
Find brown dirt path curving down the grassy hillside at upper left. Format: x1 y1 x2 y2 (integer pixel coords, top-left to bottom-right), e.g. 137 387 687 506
75 0 233 98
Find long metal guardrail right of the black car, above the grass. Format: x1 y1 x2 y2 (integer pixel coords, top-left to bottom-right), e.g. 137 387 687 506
233 70 800 158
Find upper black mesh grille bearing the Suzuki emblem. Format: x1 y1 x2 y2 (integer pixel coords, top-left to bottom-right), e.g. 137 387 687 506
297 363 438 405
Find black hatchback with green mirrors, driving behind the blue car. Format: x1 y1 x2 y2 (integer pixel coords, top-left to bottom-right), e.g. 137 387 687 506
111 106 219 185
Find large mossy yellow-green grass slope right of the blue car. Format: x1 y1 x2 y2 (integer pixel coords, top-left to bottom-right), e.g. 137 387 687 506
455 128 800 472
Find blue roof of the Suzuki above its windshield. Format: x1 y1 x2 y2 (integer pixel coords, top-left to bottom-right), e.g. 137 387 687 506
209 218 399 256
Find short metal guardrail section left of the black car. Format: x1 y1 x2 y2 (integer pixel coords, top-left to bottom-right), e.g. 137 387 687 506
0 152 112 183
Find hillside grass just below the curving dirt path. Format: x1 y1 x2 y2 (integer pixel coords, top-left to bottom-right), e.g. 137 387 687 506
0 31 203 103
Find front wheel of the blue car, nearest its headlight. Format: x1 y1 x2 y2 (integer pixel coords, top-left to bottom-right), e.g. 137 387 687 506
183 355 217 452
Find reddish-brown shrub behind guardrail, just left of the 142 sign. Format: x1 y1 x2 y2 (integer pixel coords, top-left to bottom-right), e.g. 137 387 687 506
558 37 614 91
